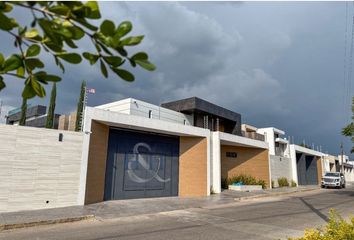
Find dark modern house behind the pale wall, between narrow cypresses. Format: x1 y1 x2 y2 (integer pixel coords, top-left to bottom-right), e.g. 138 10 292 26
6 105 60 129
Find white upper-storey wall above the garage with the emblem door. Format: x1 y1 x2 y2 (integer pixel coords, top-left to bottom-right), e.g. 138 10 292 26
96 98 193 125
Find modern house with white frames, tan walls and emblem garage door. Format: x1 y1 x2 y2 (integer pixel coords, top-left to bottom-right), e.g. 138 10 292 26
81 97 270 204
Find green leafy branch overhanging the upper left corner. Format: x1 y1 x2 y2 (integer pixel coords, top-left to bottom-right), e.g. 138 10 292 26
0 1 155 99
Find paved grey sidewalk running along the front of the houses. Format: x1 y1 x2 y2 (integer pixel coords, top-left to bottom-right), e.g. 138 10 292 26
0 186 319 231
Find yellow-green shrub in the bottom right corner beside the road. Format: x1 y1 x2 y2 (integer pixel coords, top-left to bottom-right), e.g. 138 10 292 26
289 209 354 240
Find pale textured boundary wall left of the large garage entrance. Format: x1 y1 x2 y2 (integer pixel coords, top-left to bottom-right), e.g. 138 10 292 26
0 125 83 212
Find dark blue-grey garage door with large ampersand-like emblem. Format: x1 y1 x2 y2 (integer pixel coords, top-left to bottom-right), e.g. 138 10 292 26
105 129 179 200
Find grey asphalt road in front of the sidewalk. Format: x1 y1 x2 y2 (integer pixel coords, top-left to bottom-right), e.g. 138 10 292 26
0 186 354 240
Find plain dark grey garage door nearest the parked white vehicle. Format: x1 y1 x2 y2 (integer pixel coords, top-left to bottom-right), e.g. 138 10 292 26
296 153 318 185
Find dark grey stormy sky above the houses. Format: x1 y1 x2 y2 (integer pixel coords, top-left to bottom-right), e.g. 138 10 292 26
0 2 354 157
